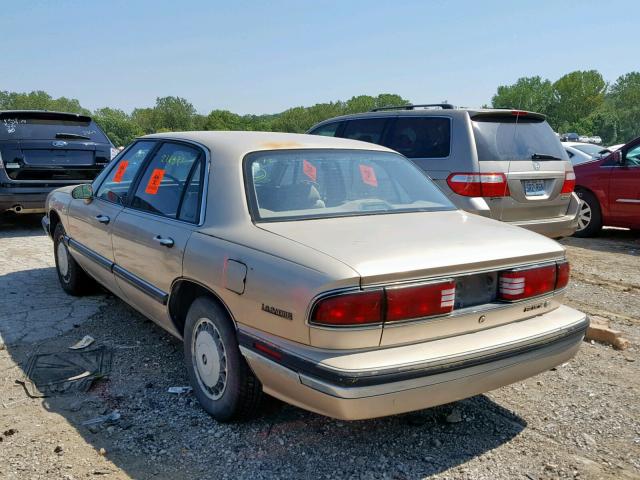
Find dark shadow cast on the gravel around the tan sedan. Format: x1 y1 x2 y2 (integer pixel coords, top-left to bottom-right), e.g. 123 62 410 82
0 216 526 479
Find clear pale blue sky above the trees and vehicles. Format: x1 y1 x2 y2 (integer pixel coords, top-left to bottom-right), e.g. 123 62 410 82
0 0 640 114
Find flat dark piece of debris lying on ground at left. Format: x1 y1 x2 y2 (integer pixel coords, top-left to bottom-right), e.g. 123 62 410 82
19 346 113 398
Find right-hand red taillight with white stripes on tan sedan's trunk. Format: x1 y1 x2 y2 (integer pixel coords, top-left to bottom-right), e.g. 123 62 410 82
498 263 557 301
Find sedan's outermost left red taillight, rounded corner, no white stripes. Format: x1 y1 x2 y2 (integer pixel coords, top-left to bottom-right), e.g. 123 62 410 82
311 290 384 326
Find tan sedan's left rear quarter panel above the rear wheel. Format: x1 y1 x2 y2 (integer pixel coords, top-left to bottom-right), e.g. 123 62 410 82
183 231 382 348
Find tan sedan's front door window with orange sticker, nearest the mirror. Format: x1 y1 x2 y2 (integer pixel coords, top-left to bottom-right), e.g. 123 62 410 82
96 142 156 205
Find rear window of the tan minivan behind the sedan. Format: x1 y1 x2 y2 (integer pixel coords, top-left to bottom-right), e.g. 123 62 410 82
473 116 566 161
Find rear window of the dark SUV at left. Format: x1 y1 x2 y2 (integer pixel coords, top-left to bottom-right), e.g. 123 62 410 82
0 113 109 143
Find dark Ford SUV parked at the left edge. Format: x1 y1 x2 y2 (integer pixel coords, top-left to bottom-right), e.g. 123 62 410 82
0 110 116 213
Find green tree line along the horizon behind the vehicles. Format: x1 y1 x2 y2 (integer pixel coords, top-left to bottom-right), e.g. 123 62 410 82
0 70 640 146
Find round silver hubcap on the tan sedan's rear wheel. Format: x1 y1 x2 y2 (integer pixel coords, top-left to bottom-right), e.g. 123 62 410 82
191 318 227 400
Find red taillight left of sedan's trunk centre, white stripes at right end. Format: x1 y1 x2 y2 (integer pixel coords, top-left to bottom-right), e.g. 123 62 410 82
386 280 456 322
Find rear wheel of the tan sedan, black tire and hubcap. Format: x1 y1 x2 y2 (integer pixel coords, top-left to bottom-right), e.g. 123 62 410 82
184 297 262 422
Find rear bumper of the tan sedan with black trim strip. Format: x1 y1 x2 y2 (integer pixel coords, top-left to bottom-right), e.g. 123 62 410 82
240 306 589 420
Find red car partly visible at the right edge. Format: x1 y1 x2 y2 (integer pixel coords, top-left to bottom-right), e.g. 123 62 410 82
573 137 640 237
